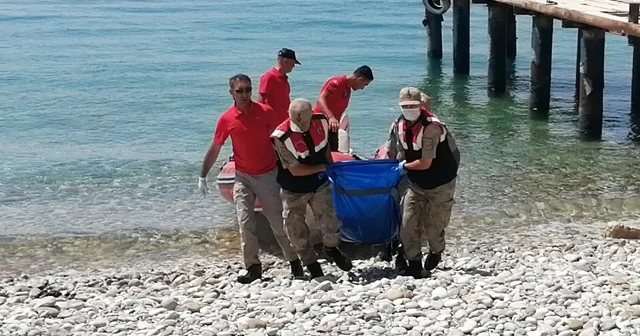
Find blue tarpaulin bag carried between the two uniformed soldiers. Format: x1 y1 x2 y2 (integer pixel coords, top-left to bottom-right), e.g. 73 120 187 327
327 159 402 244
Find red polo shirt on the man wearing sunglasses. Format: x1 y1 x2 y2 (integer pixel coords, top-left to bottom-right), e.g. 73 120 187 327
213 102 278 175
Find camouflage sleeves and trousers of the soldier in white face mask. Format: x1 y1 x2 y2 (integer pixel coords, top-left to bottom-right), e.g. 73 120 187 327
386 124 460 261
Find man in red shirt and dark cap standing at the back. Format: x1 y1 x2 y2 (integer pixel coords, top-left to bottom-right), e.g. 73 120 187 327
258 48 300 125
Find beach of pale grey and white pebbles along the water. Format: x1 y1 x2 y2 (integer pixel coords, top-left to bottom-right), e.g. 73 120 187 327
0 220 640 336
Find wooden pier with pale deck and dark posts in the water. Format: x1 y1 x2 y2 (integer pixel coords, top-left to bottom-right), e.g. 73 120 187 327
423 0 640 139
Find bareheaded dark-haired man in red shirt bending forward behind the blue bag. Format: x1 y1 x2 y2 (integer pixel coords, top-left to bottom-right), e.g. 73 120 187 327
313 65 373 152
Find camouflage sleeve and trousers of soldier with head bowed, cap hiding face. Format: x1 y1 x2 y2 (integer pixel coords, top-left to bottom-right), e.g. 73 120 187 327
274 140 340 265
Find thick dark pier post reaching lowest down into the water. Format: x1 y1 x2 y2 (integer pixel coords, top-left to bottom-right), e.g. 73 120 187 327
578 28 604 139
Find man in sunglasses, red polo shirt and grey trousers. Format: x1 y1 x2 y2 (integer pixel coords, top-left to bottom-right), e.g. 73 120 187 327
198 74 304 283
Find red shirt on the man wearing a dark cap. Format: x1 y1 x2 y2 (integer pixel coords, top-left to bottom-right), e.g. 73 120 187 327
258 67 291 125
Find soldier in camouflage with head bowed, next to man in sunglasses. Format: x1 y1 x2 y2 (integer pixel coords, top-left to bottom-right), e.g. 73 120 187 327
271 98 352 278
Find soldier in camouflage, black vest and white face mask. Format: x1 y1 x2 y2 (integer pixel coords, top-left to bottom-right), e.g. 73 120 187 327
386 87 460 278
